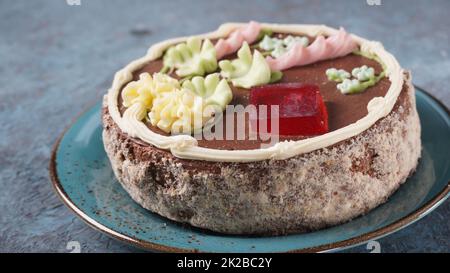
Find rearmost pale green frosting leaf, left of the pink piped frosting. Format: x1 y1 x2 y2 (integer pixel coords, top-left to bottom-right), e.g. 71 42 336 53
163 37 217 77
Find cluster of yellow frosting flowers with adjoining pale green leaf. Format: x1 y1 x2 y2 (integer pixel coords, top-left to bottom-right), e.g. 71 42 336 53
122 73 233 133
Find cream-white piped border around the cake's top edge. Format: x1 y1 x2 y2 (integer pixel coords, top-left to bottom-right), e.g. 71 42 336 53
107 23 404 162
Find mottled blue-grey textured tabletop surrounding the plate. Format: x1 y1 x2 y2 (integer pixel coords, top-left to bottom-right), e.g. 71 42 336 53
0 0 450 252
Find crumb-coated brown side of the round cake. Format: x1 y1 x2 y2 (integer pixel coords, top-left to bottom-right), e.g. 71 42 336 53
103 74 421 235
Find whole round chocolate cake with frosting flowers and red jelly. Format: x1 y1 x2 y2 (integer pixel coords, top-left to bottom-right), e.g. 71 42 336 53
102 22 421 235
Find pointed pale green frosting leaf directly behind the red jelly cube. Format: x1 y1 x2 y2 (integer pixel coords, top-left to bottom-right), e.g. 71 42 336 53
219 42 281 88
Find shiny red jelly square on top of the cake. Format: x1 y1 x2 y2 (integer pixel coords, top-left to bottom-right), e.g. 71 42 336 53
250 83 328 136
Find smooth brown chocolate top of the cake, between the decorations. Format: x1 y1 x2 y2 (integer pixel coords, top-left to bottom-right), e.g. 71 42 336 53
118 35 390 150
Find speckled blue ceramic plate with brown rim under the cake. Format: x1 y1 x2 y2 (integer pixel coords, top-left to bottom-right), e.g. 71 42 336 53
50 88 450 252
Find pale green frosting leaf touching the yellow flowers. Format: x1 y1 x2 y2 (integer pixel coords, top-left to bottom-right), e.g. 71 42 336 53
182 73 233 111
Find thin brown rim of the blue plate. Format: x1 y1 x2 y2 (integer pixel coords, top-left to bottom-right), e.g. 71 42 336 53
49 85 450 253
